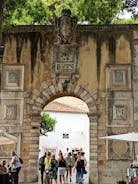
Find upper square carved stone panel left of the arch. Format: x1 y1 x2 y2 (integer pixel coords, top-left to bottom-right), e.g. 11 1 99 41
2 64 24 91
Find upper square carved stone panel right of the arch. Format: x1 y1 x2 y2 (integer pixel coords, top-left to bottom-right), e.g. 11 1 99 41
106 64 131 91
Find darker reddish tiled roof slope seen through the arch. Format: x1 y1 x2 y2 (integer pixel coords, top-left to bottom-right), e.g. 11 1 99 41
43 101 87 113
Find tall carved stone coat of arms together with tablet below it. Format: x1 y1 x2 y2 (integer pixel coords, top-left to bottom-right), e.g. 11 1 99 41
52 10 79 91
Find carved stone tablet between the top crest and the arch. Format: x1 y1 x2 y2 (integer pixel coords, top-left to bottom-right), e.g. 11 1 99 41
52 44 79 87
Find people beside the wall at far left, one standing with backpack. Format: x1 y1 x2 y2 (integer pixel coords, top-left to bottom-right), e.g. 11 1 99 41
0 151 22 184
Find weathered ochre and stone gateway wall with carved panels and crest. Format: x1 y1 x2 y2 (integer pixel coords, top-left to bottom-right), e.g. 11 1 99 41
0 11 138 184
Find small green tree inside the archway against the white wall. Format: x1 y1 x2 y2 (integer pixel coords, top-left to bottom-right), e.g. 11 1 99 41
40 112 57 135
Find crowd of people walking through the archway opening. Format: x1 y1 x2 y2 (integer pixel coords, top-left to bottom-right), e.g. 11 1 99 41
39 148 87 184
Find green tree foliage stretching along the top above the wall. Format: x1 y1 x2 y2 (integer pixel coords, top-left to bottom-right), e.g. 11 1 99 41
4 0 138 27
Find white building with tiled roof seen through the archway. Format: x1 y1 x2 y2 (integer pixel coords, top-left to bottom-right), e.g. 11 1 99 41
39 97 89 159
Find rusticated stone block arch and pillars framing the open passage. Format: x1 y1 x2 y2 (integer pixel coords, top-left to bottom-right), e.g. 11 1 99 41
26 82 98 184
